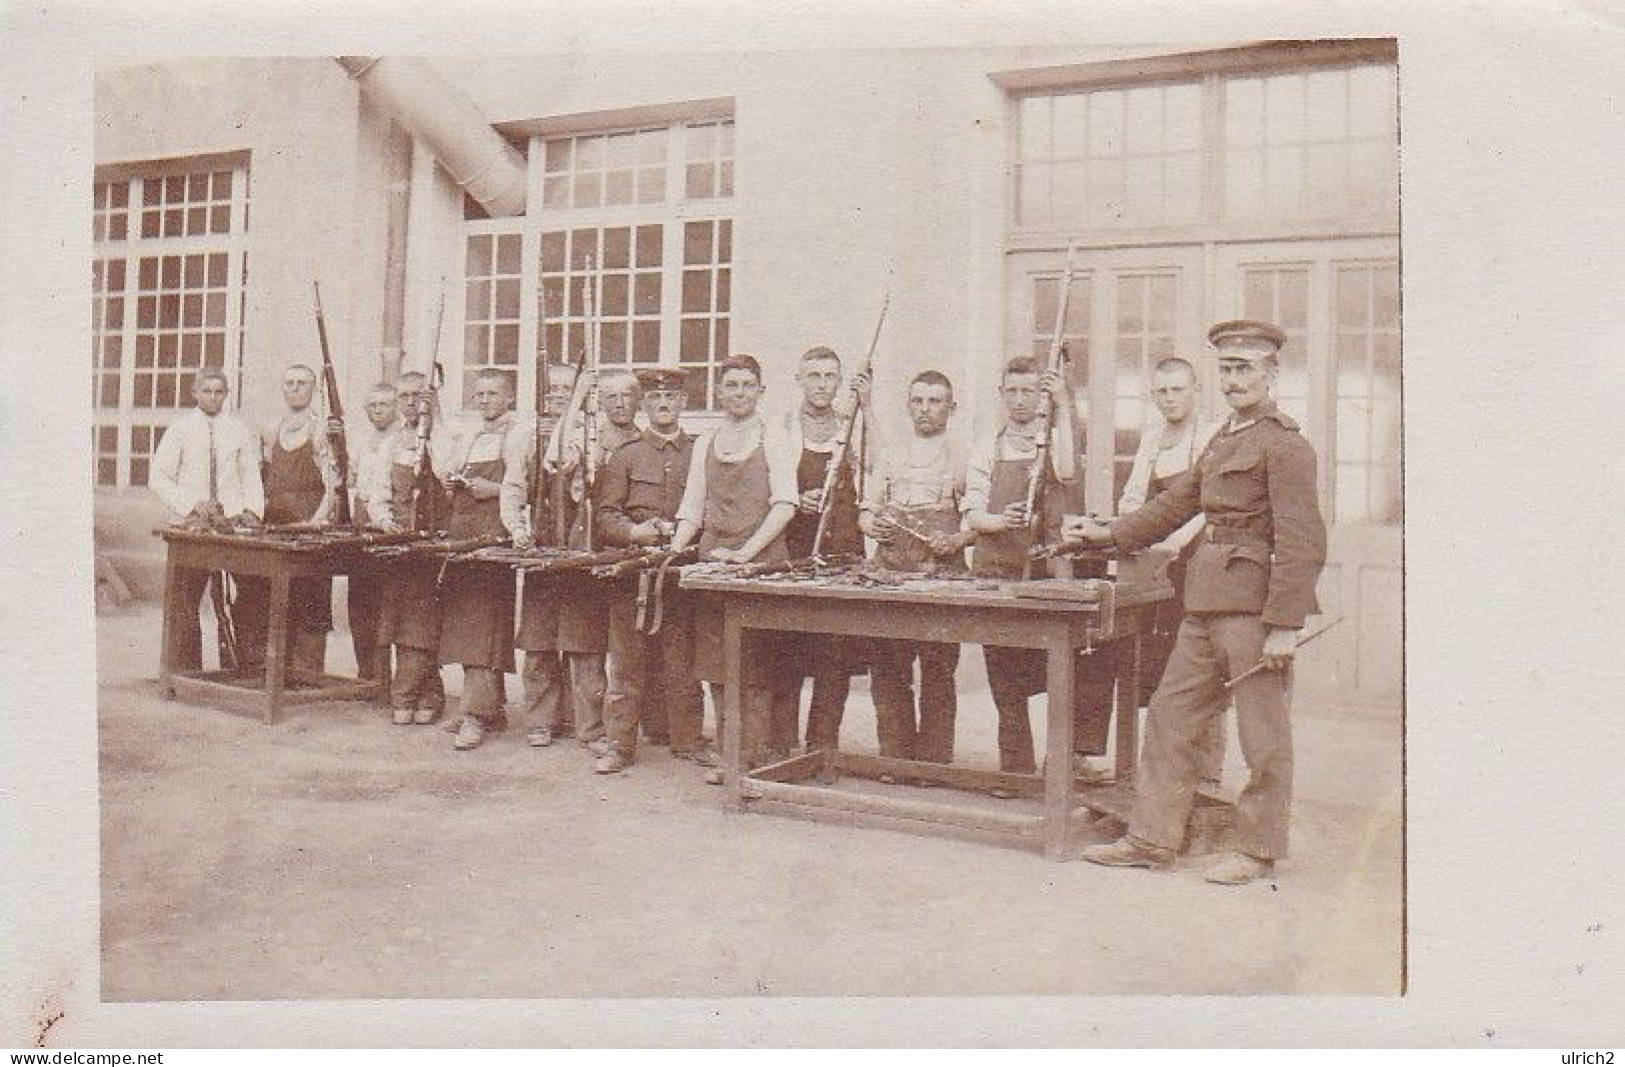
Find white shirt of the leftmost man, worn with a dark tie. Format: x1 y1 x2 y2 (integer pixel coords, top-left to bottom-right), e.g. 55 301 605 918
146 408 265 520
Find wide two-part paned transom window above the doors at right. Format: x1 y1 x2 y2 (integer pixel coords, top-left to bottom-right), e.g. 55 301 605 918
1014 63 1399 232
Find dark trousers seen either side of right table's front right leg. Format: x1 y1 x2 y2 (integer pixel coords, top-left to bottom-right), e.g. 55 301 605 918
982 645 1116 775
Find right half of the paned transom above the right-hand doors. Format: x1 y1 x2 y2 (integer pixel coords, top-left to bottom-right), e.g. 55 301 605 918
1224 65 1398 219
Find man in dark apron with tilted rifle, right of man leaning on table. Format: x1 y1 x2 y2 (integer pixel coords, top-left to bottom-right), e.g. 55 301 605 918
770 346 868 758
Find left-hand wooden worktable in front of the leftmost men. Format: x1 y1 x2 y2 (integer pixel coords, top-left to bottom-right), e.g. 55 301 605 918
158 528 388 724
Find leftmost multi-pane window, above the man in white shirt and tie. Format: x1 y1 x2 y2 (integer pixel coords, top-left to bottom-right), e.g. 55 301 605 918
91 156 249 487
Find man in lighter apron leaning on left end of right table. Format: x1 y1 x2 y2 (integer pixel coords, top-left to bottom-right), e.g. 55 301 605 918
671 354 800 784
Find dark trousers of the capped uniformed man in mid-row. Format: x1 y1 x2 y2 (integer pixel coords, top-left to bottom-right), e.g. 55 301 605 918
605 596 705 758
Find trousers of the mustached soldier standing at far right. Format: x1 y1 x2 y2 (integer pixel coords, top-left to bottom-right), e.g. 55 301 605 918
1129 616 1292 859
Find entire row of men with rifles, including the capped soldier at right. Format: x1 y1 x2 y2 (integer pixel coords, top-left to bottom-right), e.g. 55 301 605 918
153 322 1326 883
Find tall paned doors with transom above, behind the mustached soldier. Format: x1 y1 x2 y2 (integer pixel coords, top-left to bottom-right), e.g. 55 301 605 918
995 41 1401 526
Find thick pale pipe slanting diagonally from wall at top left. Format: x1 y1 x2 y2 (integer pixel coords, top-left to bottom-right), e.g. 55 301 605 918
338 55 525 218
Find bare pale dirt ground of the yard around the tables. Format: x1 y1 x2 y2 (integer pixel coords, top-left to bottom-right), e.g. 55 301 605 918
98 607 1402 1000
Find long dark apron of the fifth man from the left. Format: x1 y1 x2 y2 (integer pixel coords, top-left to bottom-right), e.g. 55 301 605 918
440 430 514 672
